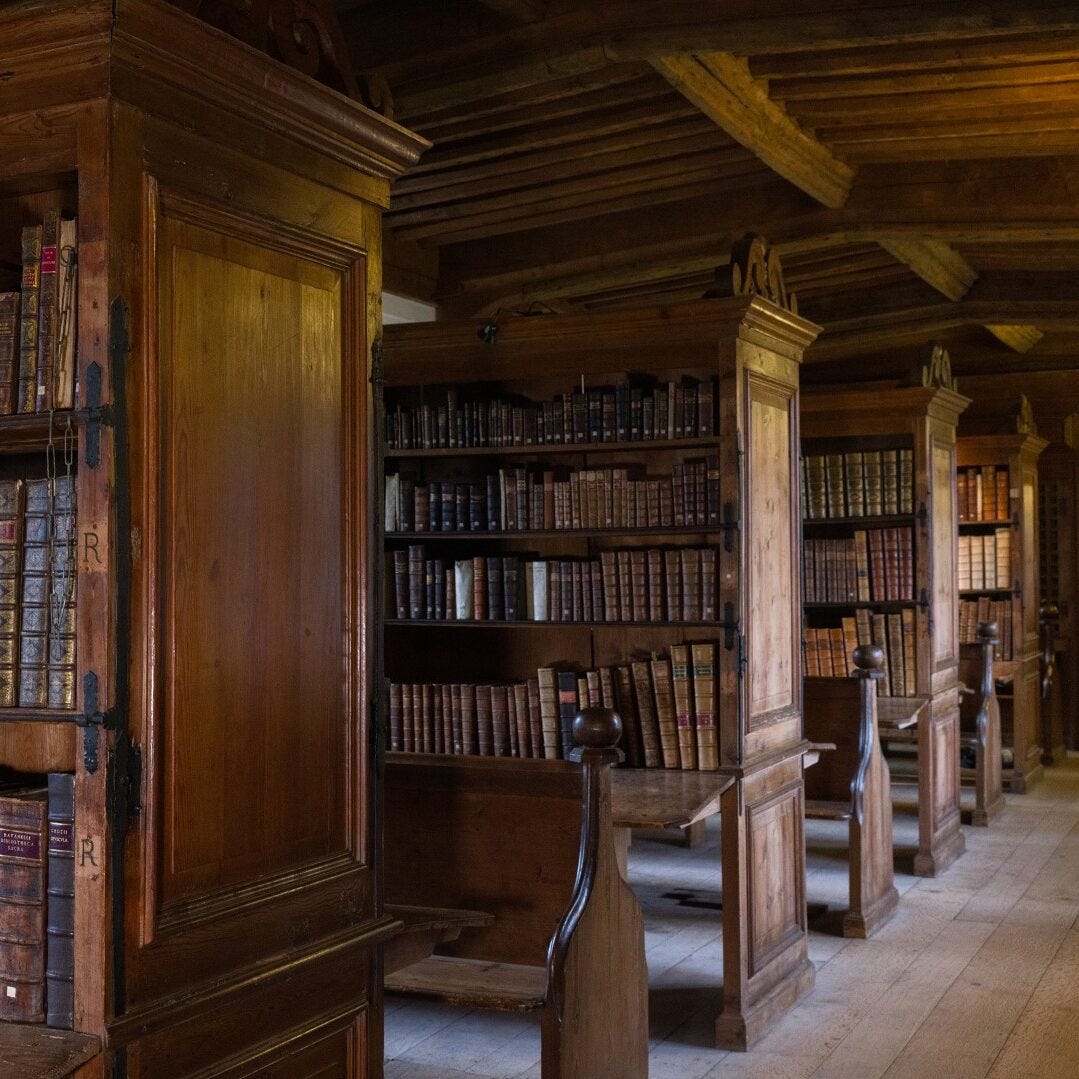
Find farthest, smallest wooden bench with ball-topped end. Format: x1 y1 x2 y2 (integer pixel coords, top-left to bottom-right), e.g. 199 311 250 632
959 622 1005 828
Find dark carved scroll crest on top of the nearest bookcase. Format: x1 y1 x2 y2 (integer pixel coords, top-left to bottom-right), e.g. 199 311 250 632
172 0 394 120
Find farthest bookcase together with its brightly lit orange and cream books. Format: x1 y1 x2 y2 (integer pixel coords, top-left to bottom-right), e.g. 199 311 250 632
956 434 1048 793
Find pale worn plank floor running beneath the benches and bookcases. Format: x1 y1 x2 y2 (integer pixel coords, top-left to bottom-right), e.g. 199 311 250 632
386 757 1079 1079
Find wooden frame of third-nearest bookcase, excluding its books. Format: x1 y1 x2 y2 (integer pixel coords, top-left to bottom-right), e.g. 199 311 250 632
802 386 969 876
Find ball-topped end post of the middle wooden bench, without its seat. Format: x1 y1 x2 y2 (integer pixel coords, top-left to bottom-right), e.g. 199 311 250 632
843 644 899 938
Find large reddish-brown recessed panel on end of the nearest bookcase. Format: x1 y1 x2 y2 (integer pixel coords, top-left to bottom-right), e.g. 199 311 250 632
160 223 346 905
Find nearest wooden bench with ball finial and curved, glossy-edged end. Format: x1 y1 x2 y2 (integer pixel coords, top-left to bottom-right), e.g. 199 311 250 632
384 709 648 1079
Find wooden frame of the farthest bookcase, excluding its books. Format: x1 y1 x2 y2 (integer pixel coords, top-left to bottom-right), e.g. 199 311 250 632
957 434 1048 794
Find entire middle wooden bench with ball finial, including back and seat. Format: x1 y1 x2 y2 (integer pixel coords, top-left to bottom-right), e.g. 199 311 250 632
804 645 899 938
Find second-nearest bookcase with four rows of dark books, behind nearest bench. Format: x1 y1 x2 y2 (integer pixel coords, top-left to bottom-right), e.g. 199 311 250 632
385 265 815 1046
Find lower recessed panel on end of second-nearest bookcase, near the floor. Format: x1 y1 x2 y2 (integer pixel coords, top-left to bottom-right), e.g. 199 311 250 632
746 782 805 976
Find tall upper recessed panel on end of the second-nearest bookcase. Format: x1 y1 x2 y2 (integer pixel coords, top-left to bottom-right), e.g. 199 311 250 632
743 378 795 730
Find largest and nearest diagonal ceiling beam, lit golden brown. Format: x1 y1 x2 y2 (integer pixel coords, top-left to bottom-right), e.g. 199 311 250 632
653 53 855 207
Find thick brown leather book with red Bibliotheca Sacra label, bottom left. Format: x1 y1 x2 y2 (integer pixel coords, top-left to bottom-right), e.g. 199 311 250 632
0 788 47 1023
